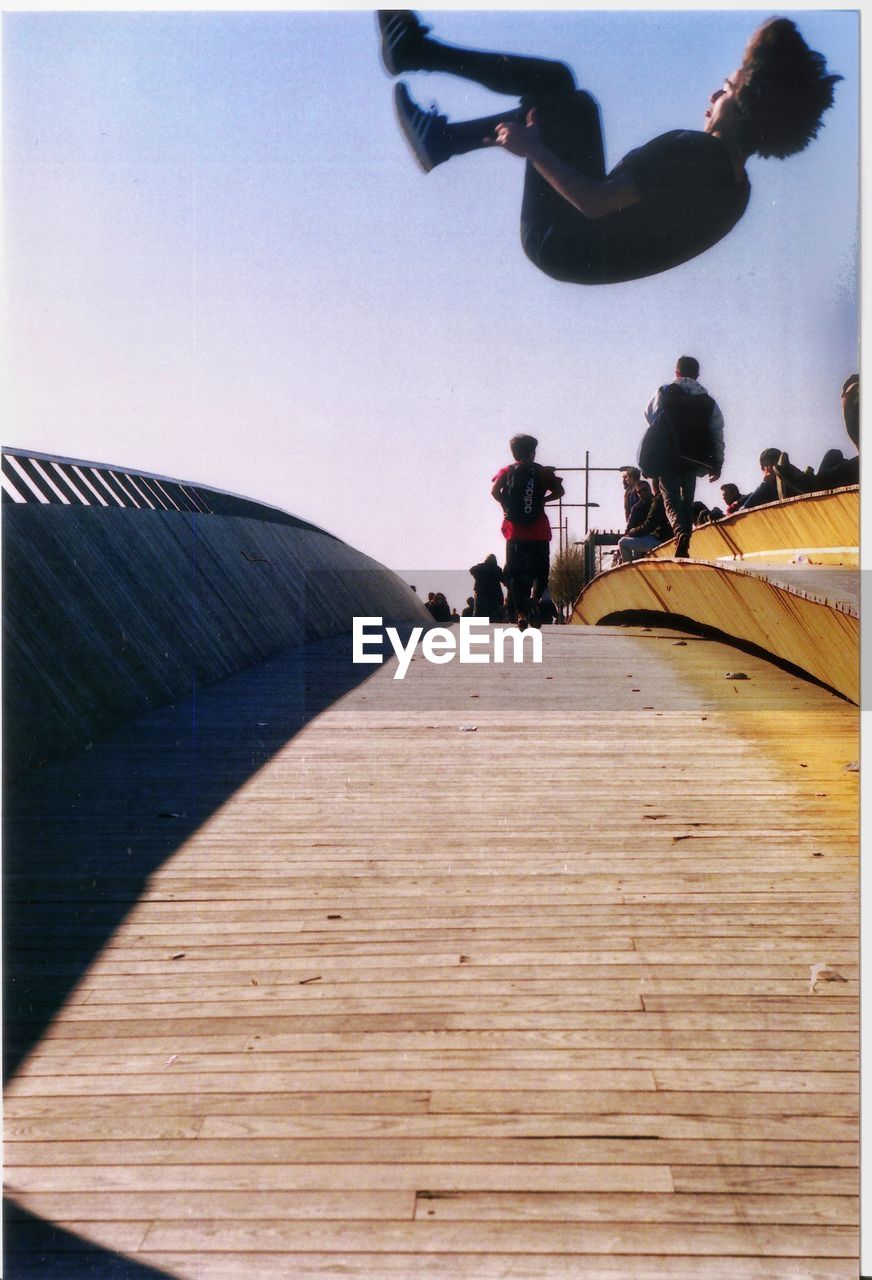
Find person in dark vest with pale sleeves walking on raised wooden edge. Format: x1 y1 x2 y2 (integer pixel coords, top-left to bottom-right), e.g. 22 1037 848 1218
639 356 723 559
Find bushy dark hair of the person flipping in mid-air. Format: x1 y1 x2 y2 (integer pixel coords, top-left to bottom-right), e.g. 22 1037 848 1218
736 18 843 160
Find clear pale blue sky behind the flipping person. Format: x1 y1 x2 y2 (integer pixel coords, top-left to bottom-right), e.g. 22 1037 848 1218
3 9 859 588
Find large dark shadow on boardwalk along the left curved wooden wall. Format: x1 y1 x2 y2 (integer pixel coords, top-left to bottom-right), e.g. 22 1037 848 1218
4 636 379 1079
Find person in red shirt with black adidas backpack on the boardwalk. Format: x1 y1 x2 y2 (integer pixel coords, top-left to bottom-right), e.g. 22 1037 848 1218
490 435 563 630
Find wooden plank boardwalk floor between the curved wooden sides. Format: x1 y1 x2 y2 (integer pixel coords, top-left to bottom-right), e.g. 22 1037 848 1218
5 627 858 1280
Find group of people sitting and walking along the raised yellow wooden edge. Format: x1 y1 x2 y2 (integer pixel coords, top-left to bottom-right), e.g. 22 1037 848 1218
618 356 859 563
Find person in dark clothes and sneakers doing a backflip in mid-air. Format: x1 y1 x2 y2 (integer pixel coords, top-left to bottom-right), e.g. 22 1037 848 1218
379 9 841 284
